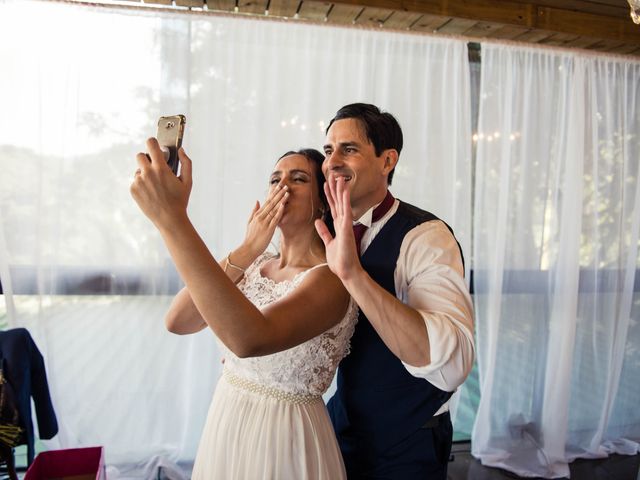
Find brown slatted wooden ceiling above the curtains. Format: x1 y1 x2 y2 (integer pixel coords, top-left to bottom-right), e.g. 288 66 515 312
70 0 640 56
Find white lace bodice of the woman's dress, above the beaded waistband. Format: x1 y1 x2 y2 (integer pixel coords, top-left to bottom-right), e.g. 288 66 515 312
219 254 358 395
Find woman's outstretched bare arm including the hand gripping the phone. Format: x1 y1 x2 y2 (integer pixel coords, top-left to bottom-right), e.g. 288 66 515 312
131 139 349 357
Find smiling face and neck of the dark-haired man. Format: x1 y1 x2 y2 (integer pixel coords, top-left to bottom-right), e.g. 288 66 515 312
322 118 388 219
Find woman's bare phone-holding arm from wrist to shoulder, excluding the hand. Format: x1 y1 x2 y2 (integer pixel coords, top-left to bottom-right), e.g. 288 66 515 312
155 210 349 357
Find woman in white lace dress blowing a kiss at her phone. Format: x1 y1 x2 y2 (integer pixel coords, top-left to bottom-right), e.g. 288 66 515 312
131 138 357 480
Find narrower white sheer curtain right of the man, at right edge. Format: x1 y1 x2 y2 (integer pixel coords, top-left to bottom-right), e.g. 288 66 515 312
472 43 640 478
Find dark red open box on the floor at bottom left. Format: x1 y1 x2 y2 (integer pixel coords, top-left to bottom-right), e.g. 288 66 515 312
24 447 107 480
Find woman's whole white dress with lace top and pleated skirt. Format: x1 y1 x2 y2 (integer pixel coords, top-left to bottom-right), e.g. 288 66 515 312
192 254 358 480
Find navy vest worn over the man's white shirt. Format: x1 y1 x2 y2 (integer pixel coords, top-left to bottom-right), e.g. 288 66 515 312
327 202 462 474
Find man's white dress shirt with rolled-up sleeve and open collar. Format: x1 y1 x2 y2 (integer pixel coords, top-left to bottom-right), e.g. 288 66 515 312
357 199 475 415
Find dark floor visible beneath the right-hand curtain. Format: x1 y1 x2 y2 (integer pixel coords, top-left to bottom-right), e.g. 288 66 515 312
447 443 640 480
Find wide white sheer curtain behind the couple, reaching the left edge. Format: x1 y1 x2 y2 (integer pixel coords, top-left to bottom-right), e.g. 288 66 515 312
0 0 471 472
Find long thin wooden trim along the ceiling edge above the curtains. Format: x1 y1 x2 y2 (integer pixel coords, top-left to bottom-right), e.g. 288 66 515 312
45 0 640 63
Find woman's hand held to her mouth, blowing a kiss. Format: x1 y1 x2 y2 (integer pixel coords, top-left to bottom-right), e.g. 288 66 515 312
242 184 289 257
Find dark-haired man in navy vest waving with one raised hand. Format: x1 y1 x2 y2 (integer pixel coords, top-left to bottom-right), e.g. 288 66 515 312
316 103 474 480
